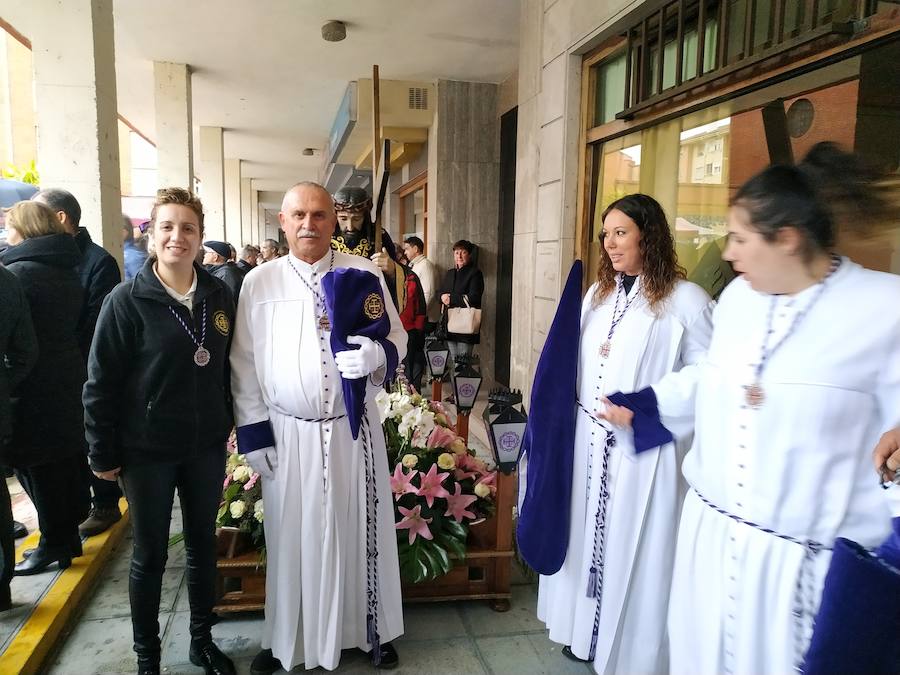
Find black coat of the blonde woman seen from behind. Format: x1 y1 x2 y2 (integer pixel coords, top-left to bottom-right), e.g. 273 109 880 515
0 234 85 468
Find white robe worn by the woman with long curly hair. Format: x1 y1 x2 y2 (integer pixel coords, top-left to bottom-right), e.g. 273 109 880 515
538 282 712 673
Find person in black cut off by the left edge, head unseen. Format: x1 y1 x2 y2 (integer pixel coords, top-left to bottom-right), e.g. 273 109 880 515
0 267 38 612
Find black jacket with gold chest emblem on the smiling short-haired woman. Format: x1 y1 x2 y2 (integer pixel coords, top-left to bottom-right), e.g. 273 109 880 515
84 259 234 471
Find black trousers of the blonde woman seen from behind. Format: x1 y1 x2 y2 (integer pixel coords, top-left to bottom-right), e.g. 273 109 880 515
16 453 87 547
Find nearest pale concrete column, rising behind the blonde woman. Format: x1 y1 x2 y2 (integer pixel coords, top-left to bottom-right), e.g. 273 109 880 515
31 0 122 267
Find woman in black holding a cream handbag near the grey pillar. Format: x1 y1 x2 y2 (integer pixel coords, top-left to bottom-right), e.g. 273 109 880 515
441 239 484 361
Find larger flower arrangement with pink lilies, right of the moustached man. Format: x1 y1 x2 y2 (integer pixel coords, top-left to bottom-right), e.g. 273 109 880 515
375 378 497 583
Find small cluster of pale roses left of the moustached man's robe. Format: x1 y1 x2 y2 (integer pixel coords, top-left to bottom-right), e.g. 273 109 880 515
216 432 266 553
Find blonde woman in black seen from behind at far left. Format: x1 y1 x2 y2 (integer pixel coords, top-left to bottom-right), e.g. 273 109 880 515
0 202 88 575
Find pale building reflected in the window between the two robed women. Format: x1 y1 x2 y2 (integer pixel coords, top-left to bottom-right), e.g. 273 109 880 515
672 117 734 297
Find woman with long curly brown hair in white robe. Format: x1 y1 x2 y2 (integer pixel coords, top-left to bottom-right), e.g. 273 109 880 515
538 195 711 673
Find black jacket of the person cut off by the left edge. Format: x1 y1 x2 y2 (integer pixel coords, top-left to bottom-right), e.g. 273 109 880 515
0 267 37 446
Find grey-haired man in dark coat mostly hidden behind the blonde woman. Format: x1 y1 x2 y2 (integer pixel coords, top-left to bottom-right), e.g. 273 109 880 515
32 188 122 537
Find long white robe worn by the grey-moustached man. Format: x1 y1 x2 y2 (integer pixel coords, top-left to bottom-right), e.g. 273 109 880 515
231 252 406 670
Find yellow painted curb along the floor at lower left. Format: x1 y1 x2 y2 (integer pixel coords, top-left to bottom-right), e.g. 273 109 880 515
0 499 128 675
